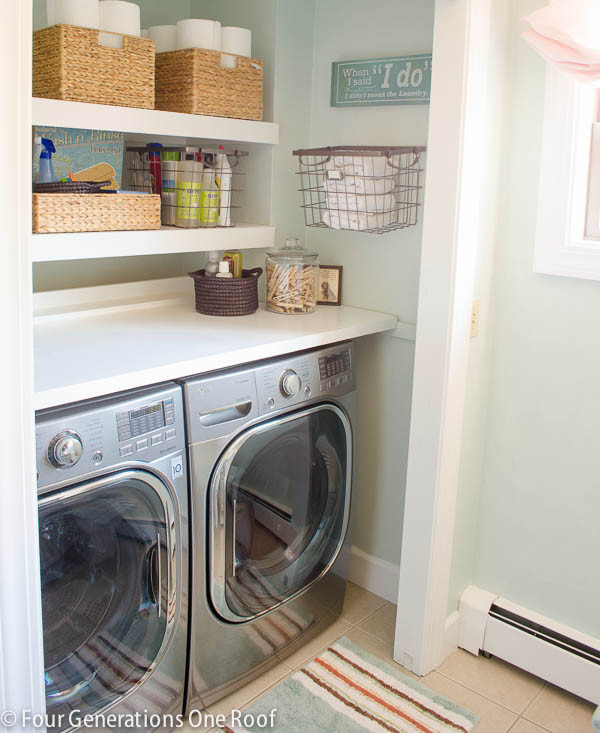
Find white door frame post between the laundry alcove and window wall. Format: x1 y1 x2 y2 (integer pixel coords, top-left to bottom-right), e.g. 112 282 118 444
394 0 502 675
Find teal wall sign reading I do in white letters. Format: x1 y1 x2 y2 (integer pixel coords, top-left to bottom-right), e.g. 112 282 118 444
331 54 431 107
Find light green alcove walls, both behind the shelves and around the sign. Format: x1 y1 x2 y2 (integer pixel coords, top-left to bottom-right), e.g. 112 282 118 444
31 0 434 563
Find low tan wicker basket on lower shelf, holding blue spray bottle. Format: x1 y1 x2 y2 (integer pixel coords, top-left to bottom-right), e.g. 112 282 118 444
33 193 160 234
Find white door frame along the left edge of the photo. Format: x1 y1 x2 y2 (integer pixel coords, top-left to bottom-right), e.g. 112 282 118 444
0 0 45 733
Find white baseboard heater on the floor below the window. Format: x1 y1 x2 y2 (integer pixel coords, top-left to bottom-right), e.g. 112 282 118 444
459 586 600 705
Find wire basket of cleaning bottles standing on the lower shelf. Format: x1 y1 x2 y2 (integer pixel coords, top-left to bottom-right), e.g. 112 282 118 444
123 144 248 229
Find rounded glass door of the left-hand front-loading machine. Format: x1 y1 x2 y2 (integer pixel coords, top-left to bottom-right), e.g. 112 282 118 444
39 470 178 716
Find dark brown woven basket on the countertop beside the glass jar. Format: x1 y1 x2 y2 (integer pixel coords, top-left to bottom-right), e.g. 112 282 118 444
189 267 262 316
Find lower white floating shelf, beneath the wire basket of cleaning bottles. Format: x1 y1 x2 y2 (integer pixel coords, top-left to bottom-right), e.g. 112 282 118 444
31 224 275 262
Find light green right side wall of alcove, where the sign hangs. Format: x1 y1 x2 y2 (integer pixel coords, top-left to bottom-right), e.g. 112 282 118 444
307 0 434 564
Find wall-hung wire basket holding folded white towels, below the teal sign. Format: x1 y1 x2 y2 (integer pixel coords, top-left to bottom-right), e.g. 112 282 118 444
294 145 426 234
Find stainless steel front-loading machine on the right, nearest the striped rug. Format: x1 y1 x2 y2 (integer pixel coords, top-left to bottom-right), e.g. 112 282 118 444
183 343 355 710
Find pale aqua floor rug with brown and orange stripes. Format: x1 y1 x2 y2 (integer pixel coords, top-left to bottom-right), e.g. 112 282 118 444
223 636 478 733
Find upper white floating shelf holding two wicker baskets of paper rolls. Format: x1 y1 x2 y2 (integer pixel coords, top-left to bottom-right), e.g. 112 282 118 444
31 97 279 145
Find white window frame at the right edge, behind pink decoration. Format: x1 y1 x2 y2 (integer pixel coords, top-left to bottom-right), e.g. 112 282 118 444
533 67 600 280
